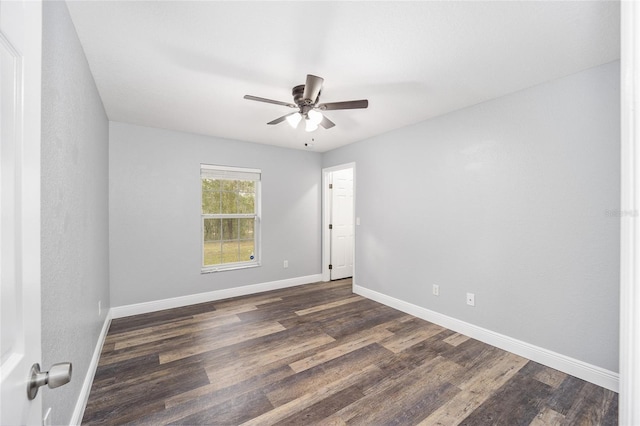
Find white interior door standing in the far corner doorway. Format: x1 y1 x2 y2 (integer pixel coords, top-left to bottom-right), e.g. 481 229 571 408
330 169 354 280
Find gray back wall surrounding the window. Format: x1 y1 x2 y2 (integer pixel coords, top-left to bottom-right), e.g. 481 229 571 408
109 122 321 306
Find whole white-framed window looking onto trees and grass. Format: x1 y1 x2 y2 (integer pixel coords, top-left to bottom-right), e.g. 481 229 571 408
200 164 261 272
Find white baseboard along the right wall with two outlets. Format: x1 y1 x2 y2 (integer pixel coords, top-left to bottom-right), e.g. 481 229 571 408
353 285 620 392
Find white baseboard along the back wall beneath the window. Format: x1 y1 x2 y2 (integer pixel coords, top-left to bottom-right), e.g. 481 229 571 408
111 274 322 318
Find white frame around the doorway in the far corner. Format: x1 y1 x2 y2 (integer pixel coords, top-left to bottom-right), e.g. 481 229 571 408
322 162 357 285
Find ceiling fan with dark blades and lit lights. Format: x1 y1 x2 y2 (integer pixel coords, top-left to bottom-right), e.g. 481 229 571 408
244 74 369 132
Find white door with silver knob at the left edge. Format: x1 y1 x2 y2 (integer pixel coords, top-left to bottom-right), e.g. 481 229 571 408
0 0 42 425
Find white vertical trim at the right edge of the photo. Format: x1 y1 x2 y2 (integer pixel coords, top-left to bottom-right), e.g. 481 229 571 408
618 1 640 425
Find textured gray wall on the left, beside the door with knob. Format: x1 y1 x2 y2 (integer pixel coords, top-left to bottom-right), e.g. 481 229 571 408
41 1 109 424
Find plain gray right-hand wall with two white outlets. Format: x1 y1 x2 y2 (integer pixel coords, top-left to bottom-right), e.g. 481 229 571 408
323 62 620 371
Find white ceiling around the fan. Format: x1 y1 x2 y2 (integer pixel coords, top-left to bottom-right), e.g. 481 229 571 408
68 1 620 152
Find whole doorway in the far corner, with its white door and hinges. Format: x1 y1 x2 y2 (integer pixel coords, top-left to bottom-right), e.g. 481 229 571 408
322 163 355 281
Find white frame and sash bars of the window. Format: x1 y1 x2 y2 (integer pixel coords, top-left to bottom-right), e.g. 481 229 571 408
200 164 262 274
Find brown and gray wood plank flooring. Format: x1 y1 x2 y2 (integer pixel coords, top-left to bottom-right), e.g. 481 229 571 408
83 280 618 426
